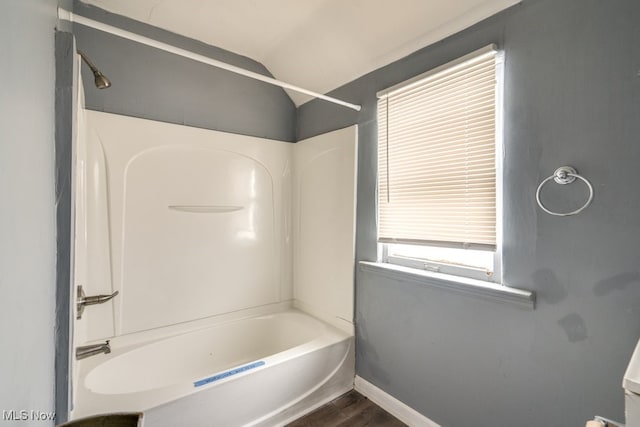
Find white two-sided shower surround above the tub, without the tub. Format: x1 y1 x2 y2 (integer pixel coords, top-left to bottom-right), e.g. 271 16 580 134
76 110 357 345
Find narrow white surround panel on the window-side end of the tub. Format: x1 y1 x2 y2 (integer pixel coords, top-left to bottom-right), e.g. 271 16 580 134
293 126 357 331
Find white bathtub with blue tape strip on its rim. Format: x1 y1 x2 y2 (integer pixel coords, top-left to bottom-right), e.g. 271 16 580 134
72 309 354 427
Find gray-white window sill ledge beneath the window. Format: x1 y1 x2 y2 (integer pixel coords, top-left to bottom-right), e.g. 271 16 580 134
360 261 536 310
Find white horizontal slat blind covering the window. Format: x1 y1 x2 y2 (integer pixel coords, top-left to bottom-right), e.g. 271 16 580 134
378 46 496 249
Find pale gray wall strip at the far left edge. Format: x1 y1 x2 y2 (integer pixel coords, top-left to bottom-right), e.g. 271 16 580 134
0 0 57 426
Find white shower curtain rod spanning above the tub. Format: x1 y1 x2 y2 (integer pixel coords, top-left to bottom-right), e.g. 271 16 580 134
58 8 362 111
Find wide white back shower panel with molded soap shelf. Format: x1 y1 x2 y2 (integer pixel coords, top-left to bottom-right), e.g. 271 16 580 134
77 111 292 340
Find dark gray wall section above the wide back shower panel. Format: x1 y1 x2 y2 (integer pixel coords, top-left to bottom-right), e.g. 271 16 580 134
73 1 296 142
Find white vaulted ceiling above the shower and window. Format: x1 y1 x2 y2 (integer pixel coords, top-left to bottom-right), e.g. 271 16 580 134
83 0 520 105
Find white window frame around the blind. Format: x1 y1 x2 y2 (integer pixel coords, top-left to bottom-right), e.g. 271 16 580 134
376 44 505 284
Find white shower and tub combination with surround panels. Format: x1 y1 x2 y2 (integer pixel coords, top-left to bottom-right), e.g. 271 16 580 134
71 110 357 427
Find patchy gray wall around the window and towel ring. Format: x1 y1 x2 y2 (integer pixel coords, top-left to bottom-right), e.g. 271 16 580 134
297 0 640 427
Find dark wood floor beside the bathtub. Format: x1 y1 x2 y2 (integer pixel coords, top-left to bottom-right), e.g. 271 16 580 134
287 390 406 427
